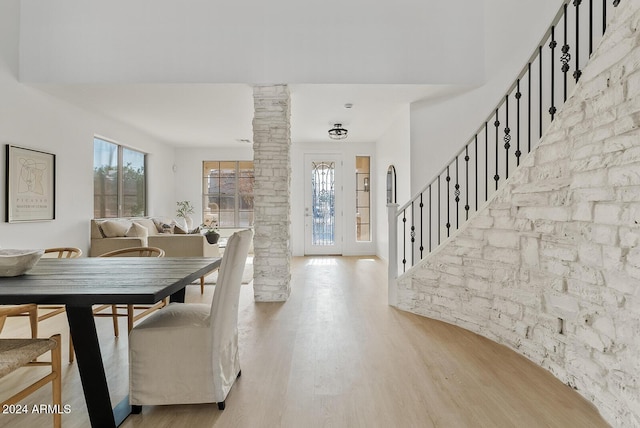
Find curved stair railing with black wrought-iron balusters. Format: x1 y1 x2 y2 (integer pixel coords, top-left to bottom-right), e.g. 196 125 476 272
388 0 620 292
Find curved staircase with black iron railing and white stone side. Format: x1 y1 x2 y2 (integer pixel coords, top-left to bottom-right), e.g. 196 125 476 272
389 0 640 426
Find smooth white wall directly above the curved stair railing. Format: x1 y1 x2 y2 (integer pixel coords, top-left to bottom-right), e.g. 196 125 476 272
408 0 562 195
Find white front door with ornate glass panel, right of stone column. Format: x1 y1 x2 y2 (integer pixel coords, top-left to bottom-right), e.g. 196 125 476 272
304 154 342 255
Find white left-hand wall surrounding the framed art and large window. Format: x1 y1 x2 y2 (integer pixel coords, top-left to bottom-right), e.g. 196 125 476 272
0 0 174 253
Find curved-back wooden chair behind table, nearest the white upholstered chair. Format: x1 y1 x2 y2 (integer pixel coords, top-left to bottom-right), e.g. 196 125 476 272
93 247 168 337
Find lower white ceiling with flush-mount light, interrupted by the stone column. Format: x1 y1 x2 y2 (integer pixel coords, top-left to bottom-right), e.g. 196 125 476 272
33 84 464 147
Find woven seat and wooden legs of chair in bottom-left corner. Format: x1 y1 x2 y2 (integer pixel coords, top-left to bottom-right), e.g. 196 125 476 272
0 334 62 428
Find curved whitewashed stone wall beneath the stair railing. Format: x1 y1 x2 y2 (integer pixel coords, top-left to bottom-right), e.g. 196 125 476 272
398 0 640 427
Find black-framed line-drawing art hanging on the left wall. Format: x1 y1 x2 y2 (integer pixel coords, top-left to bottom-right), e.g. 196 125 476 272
5 144 56 223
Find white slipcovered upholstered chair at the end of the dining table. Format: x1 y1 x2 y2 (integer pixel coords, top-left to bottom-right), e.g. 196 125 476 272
129 230 253 413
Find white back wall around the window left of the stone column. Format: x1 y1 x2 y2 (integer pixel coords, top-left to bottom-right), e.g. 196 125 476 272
175 143 253 226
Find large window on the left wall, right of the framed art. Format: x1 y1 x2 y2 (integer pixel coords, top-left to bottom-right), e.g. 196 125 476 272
93 138 147 218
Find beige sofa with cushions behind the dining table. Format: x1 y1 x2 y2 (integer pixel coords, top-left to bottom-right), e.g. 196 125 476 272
89 217 220 257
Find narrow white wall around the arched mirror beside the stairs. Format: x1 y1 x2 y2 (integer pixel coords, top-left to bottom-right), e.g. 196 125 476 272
374 105 411 260
